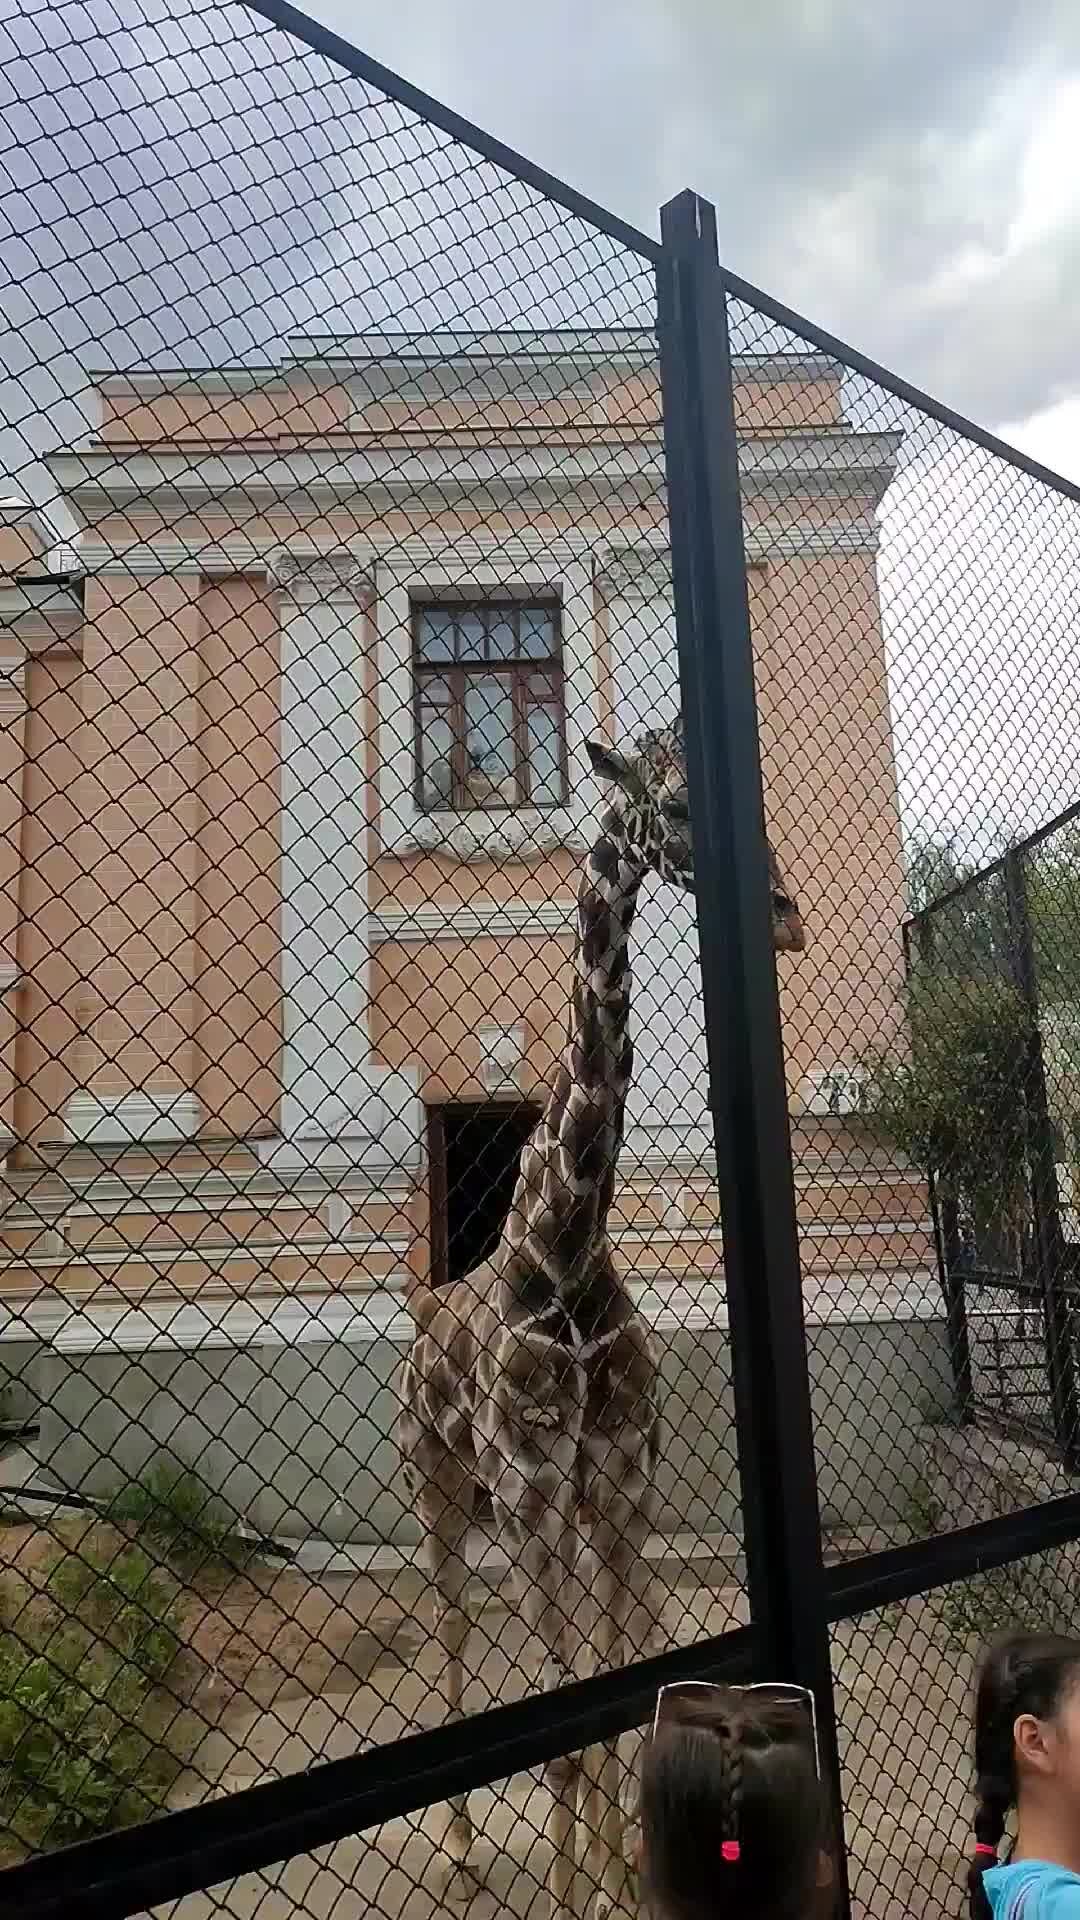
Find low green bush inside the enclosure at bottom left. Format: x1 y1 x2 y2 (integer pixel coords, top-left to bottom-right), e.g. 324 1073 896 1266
0 1540 183 1853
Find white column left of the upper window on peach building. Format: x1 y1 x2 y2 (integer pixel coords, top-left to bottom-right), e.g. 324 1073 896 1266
261 549 421 1169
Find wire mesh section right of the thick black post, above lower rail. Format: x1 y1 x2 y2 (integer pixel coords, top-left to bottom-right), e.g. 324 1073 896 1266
730 284 1080 1542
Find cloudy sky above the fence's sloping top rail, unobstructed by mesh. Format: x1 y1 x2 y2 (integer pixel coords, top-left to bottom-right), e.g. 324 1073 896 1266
295 0 1080 478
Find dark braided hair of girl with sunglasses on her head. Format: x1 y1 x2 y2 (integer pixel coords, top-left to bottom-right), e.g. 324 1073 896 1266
640 1688 828 1920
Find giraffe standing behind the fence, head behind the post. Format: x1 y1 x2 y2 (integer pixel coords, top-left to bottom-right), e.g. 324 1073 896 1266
398 720 805 1920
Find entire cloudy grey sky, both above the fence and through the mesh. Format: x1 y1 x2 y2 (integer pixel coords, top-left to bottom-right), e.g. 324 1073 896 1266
0 0 1080 851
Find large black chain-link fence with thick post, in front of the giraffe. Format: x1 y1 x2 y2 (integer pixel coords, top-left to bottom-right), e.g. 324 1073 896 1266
0 0 1080 1920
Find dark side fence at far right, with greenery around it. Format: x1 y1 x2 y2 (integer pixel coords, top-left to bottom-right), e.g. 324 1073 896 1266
909 804 1080 1469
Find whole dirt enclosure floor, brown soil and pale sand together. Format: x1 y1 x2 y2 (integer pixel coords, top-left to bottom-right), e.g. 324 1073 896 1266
0 1523 970 1920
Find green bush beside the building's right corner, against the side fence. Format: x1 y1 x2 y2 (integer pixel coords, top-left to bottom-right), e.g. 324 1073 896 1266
863 972 1030 1221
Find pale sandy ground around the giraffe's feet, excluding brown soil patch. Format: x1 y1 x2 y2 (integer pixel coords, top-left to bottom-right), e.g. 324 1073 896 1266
143 1590 970 1920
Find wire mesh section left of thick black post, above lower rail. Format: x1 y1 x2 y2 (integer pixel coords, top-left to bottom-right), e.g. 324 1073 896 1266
0 4 737 1914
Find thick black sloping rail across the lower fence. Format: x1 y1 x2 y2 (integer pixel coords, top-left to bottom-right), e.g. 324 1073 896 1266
10 1494 1080 1920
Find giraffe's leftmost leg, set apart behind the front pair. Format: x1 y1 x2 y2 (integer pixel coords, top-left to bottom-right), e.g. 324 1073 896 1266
421 1484 480 1903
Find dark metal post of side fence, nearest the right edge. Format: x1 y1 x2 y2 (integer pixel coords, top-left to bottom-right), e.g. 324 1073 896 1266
1005 851 1080 1469
